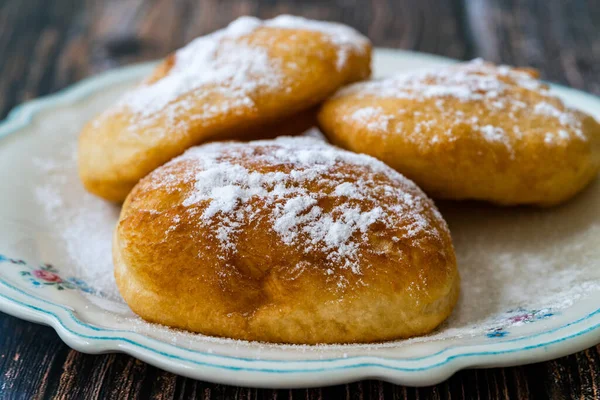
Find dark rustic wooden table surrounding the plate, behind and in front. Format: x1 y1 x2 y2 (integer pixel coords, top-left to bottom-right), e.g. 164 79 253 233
0 0 600 399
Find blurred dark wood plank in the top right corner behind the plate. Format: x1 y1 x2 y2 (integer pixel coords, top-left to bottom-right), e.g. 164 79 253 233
465 0 600 93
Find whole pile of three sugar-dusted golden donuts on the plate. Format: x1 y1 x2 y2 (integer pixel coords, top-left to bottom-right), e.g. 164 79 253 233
78 16 600 344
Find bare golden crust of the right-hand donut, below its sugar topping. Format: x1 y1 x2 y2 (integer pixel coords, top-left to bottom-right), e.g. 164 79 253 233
318 63 600 206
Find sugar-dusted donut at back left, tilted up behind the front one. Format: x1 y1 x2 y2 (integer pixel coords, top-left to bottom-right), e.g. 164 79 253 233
78 15 371 202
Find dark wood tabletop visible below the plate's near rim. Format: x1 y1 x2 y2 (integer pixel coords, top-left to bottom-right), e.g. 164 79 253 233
0 315 600 400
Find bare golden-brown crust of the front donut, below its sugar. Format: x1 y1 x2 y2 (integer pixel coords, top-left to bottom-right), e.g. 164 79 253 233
113 141 459 344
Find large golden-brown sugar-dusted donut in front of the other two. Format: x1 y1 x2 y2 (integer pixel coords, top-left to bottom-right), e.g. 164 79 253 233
113 137 459 344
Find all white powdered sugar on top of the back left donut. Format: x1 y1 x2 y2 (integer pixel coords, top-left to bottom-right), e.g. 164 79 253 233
119 15 368 124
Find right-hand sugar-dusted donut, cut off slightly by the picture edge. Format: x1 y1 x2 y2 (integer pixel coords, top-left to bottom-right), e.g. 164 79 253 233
318 60 600 206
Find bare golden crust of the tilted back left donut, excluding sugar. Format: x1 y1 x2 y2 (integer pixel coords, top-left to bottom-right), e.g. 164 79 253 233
79 27 371 201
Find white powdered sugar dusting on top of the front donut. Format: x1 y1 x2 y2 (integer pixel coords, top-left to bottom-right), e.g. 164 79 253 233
150 137 441 274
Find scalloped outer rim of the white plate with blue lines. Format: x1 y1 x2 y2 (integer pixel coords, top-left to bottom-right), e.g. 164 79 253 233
0 49 600 387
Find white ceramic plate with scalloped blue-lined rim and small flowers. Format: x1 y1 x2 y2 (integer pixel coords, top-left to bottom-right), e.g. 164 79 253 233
0 50 600 388
